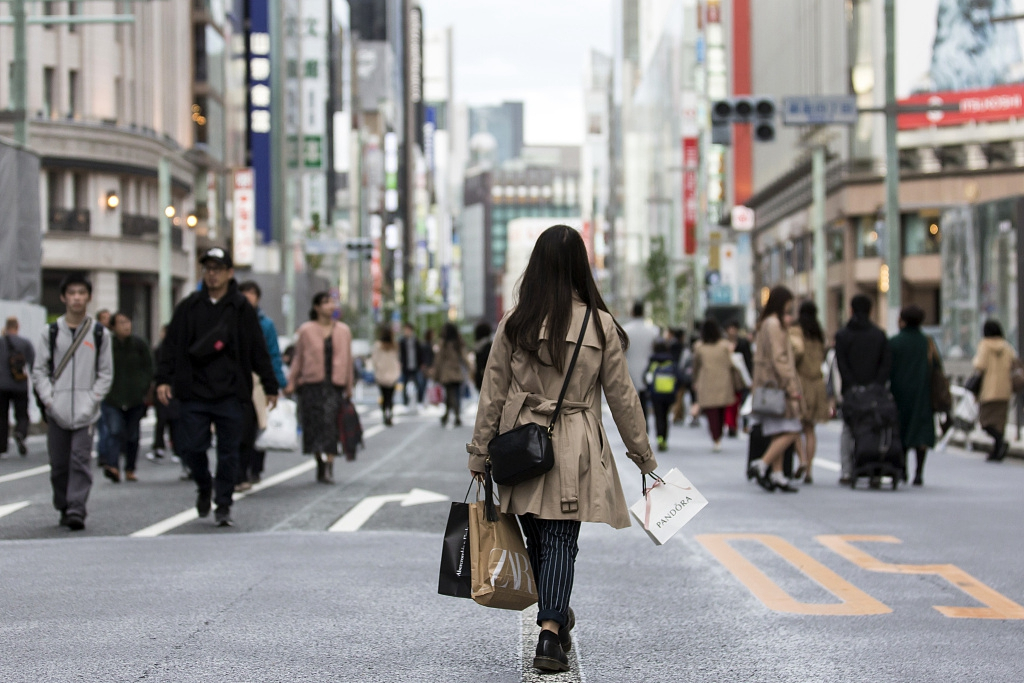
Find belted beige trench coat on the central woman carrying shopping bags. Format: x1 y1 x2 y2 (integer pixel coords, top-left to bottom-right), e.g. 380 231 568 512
466 300 657 528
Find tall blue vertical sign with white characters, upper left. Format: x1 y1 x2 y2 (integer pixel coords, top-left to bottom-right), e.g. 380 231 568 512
247 0 273 245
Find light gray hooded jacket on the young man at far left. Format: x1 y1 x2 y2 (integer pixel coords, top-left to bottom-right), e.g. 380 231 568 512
32 315 114 429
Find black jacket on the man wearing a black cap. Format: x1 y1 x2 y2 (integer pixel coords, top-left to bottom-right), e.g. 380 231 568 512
156 280 279 401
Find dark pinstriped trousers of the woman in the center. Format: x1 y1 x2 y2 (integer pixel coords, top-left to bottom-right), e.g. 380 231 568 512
519 515 581 627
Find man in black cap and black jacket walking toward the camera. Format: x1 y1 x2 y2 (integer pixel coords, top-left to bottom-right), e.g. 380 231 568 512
157 247 279 526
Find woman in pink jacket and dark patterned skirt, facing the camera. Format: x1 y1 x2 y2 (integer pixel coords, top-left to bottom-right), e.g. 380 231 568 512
287 292 355 483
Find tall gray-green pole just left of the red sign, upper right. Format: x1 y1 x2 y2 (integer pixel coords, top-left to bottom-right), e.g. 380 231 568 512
885 0 903 334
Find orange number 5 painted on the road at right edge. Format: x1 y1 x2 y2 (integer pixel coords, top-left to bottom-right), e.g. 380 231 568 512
816 535 1024 620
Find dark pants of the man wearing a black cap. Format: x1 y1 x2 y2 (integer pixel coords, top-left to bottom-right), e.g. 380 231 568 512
175 397 245 508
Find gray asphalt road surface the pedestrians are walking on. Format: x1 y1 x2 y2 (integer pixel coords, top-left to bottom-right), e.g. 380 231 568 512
0 397 1024 682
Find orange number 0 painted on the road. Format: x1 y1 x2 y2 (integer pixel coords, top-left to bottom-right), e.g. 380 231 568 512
697 533 892 616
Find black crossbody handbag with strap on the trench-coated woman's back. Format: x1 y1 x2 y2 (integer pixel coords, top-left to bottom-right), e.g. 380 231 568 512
486 306 590 486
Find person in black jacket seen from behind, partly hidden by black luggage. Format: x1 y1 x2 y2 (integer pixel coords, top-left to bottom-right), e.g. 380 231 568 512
836 294 892 484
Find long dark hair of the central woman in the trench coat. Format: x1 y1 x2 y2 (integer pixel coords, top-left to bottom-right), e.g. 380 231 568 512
505 225 630 373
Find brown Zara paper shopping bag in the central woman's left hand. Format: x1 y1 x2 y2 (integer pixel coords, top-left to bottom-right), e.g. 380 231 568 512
469 502 537 611
